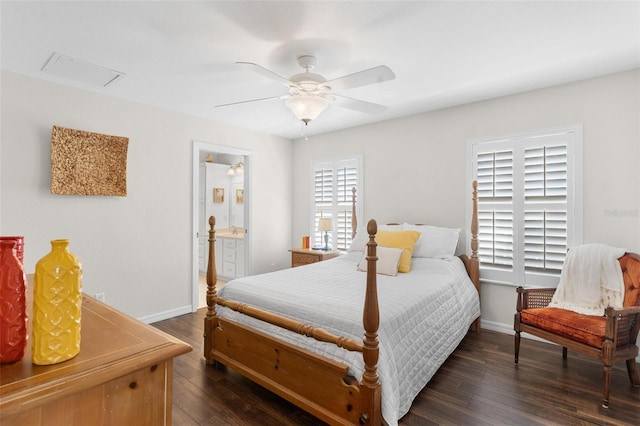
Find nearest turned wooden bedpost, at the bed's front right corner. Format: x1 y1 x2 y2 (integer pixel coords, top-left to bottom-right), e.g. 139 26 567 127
360 219 382 426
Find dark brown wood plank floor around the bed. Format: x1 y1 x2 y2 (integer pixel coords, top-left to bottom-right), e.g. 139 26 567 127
153 310 640 426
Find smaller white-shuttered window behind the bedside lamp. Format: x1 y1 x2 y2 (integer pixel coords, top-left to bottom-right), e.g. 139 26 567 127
311 157 362 250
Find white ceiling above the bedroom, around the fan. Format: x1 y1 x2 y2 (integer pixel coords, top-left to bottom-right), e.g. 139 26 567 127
0 0 640 139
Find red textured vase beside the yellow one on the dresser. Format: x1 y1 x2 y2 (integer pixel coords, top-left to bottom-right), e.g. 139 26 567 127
0 239 28 363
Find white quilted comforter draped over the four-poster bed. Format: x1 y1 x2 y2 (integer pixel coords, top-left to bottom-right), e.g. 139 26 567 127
217 252 480 425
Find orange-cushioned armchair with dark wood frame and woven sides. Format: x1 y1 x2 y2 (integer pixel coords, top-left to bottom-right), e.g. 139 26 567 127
513 253 640 408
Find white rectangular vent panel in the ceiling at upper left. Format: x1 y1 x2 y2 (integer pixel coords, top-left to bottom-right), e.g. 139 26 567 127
42 52 126 87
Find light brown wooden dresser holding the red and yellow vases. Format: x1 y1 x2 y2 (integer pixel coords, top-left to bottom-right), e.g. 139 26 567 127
0 286 191 426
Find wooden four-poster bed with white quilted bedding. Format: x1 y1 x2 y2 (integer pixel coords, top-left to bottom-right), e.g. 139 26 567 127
204 182 480 425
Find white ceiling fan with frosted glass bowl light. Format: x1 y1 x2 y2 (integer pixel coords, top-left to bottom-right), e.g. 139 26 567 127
216 55 396 125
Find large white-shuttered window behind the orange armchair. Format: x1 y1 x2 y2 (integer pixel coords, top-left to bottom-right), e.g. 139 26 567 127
470 128 582 286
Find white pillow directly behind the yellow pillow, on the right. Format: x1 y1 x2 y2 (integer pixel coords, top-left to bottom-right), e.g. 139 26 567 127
404 223 460 259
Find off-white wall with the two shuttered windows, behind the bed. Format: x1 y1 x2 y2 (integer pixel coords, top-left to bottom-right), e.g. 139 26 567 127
292 70 640 331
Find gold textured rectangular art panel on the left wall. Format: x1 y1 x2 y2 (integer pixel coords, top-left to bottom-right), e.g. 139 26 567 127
51 126 129 196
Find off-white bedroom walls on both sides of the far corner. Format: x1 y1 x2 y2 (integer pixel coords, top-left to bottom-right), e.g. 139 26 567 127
0 70 640 331
